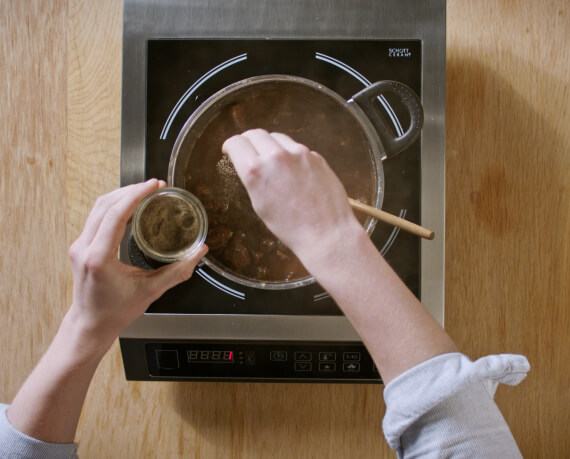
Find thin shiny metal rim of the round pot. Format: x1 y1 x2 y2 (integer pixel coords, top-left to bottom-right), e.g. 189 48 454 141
167 74 386 290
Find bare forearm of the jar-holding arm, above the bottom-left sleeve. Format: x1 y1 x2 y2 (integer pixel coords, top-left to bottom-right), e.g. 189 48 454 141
6 309 108 443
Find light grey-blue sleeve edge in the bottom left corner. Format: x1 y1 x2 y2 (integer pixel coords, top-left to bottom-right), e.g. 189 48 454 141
0 404 77 459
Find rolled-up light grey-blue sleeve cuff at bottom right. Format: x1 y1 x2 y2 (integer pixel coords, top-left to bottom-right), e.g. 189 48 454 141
383 353 530 458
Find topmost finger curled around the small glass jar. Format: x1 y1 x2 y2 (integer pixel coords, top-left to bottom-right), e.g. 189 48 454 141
91 179 158 254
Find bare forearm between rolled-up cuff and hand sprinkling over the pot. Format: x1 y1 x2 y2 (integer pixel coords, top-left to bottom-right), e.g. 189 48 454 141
301 223 457 383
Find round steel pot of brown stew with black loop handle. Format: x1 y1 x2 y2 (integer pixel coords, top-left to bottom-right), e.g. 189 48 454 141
168 75 423 289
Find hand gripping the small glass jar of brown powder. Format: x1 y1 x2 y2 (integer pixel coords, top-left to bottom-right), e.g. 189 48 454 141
69 179 208 348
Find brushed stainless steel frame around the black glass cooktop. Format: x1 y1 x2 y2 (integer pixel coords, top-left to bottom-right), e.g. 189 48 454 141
121 0 445 342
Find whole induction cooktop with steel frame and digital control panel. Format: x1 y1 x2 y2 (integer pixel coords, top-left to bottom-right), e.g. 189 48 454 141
120 0 445 383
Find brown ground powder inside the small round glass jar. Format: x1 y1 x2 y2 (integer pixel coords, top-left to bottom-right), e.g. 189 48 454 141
139 195 199 254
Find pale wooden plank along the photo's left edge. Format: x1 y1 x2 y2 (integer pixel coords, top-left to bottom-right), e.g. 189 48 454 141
0 1 70 402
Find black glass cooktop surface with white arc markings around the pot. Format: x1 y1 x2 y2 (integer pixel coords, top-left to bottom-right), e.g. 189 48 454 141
140 39 422 315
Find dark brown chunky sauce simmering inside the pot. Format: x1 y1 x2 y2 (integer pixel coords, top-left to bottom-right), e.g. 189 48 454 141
175 82 377 282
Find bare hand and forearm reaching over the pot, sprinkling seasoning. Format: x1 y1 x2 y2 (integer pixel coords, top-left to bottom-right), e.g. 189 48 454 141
222 129 456 382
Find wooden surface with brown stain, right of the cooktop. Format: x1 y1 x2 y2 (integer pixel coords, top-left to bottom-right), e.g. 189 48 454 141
446 1 570 457
